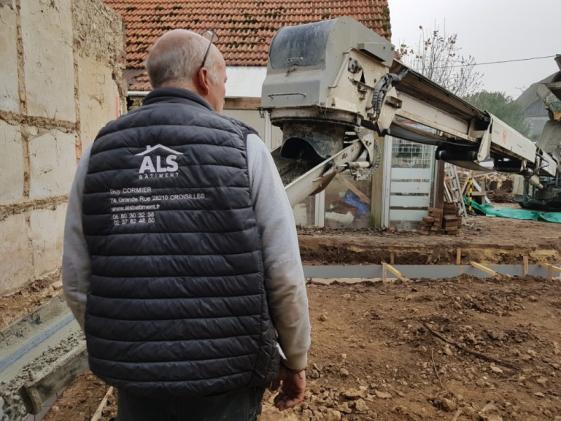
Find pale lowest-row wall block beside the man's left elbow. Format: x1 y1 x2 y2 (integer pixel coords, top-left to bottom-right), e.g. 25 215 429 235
30 203 66 278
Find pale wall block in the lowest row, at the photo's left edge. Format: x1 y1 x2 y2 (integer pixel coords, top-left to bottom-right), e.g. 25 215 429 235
0 214 33 295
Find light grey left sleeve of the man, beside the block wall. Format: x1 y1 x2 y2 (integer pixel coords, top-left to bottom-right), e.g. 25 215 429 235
62 148 91 329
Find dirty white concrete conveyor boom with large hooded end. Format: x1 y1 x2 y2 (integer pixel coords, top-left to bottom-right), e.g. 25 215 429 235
262 17 561 208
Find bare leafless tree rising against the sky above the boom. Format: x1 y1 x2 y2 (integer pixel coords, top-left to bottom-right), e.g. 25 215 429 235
399 26 482 97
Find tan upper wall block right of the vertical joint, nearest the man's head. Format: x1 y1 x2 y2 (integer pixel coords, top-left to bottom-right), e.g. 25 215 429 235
78 57 121 150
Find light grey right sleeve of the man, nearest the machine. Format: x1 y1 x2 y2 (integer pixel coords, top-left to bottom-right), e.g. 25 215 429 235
247 134 310 369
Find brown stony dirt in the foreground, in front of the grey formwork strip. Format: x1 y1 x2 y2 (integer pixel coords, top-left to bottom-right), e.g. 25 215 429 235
43 277 561 421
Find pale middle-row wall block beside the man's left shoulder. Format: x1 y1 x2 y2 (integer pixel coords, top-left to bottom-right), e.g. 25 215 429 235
29 130 76 199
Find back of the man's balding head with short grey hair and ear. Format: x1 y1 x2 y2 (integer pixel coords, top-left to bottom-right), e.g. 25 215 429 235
146 29 217 89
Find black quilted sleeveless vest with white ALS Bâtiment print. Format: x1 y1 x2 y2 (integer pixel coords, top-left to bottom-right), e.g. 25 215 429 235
83 88 278 397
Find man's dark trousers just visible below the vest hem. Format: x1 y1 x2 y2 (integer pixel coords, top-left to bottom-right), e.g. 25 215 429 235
117 388 265 421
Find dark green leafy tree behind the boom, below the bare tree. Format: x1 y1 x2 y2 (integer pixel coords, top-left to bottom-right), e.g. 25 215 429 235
464 91 530 136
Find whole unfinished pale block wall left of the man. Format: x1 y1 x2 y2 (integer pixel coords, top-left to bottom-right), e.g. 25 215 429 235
0 0 125 295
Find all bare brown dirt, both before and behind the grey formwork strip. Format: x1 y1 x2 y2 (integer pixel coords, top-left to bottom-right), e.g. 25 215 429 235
4 217 561 421
